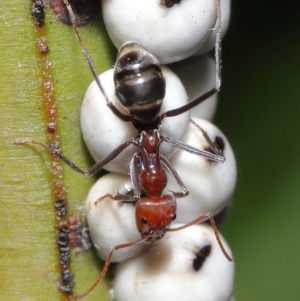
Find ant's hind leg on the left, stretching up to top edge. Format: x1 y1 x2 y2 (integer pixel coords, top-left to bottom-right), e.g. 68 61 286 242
63 0 132 122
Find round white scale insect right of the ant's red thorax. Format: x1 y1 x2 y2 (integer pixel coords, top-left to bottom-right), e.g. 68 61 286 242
165 118 237 223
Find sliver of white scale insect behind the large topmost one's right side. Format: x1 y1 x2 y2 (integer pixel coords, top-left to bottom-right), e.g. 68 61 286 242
195 0 231 55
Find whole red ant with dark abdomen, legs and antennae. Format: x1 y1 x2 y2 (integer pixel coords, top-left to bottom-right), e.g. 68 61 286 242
16 0 232 300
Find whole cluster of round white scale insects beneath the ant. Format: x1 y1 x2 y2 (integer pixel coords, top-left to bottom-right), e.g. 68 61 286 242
74 0 237 301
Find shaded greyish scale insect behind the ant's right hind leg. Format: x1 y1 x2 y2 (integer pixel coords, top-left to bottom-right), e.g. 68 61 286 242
169 55 218 120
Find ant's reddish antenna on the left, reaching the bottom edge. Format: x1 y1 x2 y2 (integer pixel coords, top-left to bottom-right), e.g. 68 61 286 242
75 235 150 300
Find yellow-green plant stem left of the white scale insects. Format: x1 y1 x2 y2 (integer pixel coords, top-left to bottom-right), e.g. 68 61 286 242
0 0 115 301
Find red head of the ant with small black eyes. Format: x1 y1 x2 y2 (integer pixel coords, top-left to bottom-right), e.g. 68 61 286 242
135 195 176 242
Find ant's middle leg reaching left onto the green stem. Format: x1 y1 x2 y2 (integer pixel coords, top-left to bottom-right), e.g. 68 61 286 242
14 138 135 176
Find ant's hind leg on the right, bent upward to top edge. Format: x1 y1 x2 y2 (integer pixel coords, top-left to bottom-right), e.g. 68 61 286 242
160 0 222 120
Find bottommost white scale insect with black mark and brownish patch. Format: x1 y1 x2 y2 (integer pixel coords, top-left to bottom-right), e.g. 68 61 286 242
113 224 234 301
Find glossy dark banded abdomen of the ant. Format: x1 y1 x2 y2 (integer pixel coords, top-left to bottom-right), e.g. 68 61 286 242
114 42 166 124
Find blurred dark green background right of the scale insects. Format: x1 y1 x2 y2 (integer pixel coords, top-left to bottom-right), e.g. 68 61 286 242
215 0 300 301
